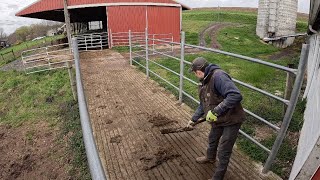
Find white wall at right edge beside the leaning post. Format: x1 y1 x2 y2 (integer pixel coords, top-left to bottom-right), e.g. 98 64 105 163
290 35 320 180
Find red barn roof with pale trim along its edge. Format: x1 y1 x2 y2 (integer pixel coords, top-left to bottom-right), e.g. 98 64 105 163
16 0 191 22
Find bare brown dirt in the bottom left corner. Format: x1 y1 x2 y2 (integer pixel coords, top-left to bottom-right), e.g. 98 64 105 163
0 122 70 179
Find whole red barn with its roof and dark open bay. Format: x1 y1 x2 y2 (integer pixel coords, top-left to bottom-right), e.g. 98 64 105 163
16 0 190 47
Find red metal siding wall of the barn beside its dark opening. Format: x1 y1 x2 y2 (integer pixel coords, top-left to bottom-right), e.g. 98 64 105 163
107 6 180 42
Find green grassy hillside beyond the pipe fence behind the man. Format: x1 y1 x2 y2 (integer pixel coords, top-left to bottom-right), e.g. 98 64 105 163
132 10 306 178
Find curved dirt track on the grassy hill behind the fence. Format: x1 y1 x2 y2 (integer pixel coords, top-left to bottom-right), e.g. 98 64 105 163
199 23 232 49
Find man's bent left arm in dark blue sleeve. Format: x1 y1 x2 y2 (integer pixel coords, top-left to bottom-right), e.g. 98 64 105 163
213 72 242 115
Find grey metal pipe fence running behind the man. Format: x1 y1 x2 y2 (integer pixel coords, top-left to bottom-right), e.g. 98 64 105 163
129 29 308 173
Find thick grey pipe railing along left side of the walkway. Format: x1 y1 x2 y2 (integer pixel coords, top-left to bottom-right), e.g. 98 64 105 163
72 38 106 180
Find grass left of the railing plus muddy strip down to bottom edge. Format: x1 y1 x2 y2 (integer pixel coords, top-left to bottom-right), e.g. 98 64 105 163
0 70 90 179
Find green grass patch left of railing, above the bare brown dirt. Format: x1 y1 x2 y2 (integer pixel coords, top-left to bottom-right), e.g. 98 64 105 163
0 71 72 126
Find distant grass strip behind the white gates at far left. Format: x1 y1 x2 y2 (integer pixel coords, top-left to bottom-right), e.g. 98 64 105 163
0 35 65 67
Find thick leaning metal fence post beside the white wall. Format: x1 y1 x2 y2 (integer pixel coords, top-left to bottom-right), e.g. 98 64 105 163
262 44 309 173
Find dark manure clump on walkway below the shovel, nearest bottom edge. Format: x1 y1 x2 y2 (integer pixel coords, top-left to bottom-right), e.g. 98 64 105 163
140 147 181 171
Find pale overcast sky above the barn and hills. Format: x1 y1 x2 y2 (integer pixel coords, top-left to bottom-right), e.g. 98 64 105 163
0 0 310 34
